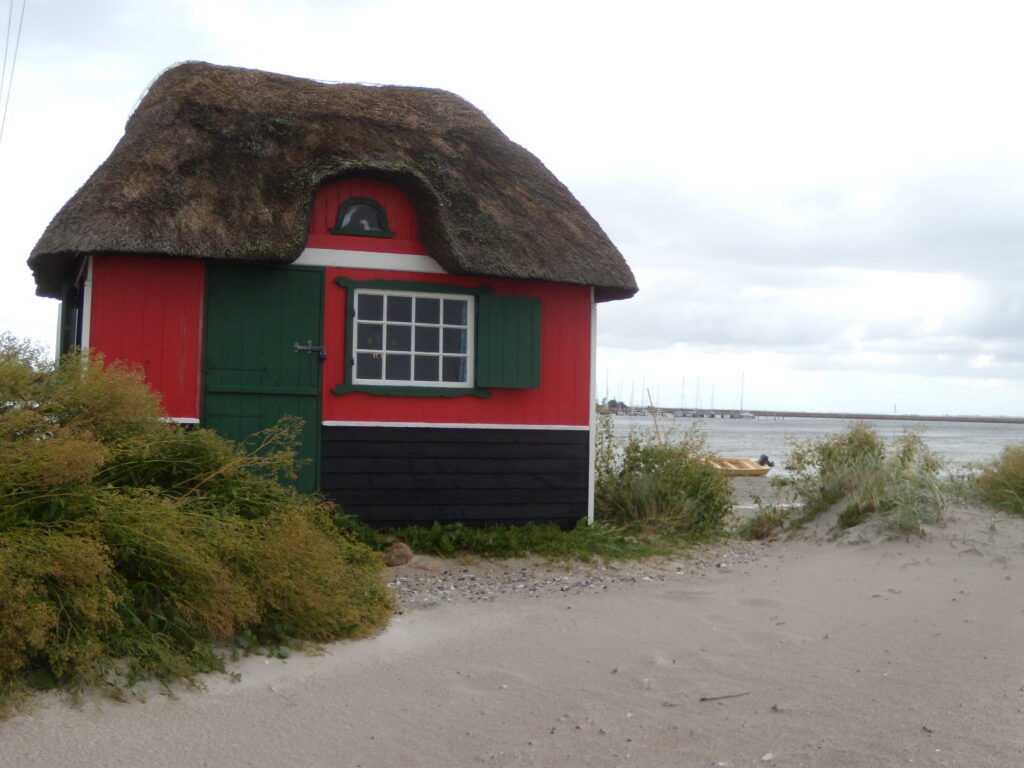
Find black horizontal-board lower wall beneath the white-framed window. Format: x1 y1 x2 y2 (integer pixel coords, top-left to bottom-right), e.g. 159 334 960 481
321 426 590 527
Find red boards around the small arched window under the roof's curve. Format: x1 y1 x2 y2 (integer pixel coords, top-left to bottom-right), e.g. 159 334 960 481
306 178 426 254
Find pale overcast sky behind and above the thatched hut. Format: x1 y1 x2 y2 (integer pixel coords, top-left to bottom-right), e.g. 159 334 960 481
0 0 1024 416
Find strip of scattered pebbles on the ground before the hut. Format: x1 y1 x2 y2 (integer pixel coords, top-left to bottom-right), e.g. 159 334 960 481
389 542 770 610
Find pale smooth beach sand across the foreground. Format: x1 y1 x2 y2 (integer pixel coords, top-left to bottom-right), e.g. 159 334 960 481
0 501 1024 768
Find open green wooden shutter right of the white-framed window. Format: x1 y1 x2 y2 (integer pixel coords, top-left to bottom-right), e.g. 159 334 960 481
476 294 541 389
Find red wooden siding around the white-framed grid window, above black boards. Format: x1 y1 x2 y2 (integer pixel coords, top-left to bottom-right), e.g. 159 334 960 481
323 268 591 426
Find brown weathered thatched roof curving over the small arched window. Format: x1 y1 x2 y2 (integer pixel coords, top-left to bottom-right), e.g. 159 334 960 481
29 61 637 300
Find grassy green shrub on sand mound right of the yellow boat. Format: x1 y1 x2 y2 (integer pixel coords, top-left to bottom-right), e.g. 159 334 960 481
772 422 946 534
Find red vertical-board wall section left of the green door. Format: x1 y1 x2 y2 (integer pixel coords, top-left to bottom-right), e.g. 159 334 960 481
89 256 204 419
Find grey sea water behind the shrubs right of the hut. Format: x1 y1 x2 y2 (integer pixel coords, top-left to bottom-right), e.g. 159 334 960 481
612 416 1024 473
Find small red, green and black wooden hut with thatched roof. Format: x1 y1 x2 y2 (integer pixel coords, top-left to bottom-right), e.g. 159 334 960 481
29 62 637 525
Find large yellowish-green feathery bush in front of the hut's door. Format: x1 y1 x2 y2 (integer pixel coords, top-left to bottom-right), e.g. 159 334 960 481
0 334 392 714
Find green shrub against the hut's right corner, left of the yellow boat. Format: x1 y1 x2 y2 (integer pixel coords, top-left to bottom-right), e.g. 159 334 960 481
594 416 732 539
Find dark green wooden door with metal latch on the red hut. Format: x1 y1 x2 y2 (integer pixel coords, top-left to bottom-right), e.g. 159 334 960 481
203 262 324 492
